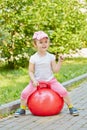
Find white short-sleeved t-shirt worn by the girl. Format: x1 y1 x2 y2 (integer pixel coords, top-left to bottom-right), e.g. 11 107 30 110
30 52 55 81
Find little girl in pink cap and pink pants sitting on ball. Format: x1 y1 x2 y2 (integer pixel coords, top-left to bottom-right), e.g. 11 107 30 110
15 31 79 116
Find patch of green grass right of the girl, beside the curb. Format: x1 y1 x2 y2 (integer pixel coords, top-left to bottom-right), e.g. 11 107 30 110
55 58 87 82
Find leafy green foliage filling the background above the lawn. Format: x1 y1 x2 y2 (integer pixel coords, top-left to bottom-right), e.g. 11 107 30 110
0 0 87 67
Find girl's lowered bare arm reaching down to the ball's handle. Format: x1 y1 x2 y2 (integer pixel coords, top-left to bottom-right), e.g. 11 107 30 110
29 63 39 86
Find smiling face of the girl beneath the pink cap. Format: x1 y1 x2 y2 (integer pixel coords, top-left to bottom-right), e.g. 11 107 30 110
35 38 49 53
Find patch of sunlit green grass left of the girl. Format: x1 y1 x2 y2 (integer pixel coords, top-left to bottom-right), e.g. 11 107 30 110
0 68 29 104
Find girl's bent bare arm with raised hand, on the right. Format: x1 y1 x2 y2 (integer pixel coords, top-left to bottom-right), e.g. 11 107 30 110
52 55 64 73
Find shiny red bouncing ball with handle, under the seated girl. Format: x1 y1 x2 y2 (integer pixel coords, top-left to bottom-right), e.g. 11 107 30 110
27 83 64 116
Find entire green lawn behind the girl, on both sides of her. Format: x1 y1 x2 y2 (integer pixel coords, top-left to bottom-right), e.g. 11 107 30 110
0 58 87 105
